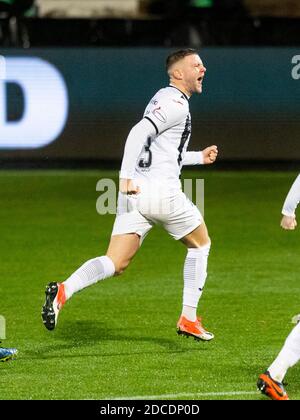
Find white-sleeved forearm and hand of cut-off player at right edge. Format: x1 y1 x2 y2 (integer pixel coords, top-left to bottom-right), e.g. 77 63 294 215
280 175 300 230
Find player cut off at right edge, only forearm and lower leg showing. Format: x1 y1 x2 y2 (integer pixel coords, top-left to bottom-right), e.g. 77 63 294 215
257 175 300 401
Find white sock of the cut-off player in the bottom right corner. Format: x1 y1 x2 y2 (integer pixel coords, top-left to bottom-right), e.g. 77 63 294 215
268 323 300 382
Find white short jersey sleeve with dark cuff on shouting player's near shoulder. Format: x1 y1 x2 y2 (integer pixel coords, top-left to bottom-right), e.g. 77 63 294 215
144 97 189 135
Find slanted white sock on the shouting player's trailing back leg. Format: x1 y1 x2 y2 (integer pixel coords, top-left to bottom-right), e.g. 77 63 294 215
63 256 115 300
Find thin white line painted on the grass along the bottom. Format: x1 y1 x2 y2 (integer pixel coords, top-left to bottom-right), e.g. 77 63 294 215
106 391 259 401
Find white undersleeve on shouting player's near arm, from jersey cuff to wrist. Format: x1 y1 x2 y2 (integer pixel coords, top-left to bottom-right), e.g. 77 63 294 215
120 118 156 180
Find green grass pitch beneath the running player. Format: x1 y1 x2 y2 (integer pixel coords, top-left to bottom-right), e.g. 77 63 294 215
0 171 300 400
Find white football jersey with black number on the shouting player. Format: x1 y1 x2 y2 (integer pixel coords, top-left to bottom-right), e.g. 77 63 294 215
135 86 192 188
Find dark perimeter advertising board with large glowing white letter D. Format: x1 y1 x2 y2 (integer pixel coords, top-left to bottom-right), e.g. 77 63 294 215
0 48 300 161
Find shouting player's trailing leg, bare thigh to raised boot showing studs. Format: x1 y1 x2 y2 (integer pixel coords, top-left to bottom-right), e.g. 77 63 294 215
42 233 140 330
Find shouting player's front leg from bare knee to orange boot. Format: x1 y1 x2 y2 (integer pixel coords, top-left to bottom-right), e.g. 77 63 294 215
177 223 214 341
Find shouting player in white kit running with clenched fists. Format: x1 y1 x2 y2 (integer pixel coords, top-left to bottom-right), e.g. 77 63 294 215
42 49 218 341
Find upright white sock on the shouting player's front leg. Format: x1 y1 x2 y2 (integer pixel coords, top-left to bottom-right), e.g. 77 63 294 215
182 244 210 322
